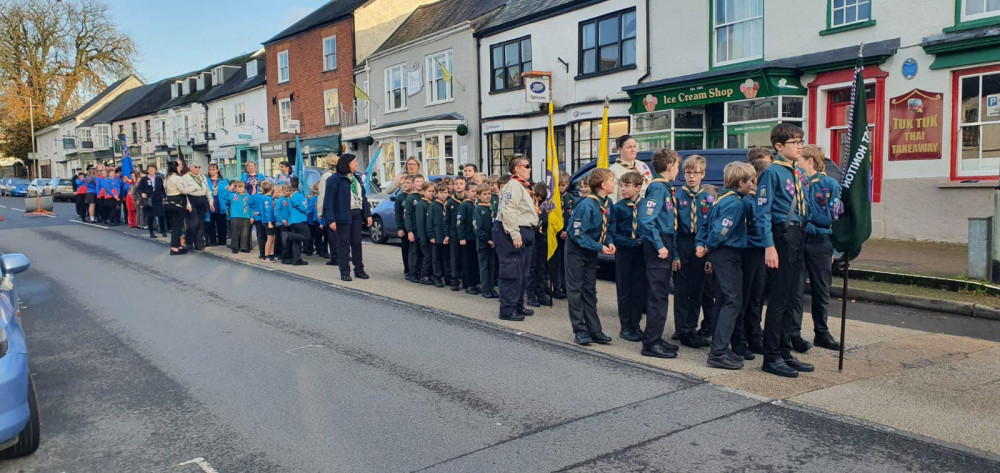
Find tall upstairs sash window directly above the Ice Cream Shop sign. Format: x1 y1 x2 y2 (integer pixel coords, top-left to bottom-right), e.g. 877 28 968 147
712 0 764 66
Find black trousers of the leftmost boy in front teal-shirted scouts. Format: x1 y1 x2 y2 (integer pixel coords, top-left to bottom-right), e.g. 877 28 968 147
566 240 603 334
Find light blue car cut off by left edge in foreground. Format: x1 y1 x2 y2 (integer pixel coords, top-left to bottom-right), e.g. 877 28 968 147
0 254 41 459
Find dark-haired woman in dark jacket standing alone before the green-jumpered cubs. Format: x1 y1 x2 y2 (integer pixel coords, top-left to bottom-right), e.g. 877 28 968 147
323 154 372 281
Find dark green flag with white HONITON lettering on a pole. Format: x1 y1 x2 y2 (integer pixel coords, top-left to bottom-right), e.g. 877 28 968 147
833 50 872 255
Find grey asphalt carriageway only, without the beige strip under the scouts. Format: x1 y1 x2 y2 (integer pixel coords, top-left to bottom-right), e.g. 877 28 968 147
0 198 1000 473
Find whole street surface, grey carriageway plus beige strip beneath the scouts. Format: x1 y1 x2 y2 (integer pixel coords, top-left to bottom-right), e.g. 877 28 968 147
0 201 1000 472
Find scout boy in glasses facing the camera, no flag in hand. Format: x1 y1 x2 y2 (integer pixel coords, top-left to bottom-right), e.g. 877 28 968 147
673 154 713 348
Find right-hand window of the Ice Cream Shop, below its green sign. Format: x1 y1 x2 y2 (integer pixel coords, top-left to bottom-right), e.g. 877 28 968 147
725 96 804 148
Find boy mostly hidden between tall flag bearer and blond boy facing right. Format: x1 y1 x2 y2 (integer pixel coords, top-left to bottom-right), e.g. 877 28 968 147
732 159 771 360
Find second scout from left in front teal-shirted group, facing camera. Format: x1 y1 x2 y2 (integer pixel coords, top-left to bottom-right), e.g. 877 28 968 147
611 171 649 342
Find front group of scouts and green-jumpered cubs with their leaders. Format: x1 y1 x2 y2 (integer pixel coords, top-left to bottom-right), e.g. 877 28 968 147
396 124 842 378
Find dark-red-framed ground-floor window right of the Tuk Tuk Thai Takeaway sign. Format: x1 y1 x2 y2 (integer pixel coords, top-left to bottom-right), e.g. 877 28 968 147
956 71 1000 177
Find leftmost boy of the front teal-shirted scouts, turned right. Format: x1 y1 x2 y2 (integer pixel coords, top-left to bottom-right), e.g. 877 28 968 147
566 168 615 345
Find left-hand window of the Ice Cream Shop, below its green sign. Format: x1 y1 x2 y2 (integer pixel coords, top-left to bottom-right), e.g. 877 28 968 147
631 107 705 151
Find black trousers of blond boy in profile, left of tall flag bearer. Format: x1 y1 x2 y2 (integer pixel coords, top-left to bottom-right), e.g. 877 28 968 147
708 246 743 357
